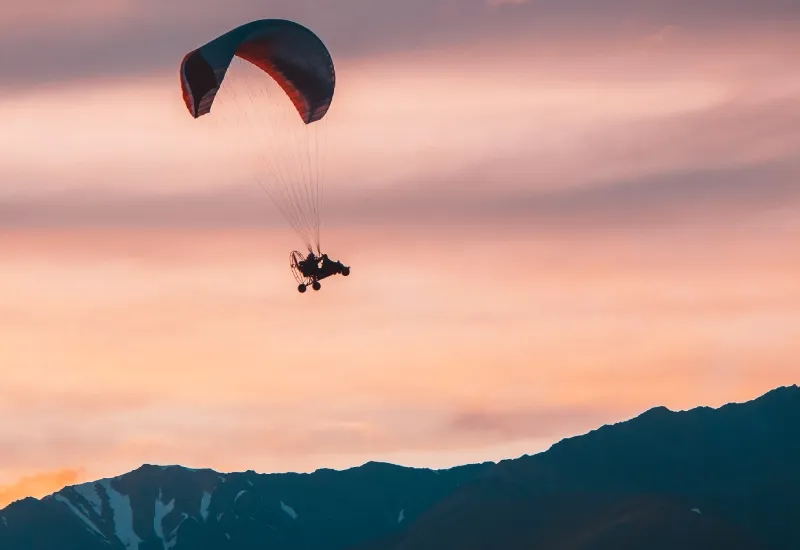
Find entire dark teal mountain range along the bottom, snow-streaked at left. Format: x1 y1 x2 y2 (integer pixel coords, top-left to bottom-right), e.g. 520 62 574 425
0 386 800 550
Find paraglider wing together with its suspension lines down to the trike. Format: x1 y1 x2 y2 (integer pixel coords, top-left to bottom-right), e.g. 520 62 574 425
180 19 336 252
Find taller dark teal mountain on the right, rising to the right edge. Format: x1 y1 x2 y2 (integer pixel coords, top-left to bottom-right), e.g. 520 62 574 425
359 386 800 550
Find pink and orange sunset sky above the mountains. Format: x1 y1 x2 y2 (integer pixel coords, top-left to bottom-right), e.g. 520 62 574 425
0 0 800 506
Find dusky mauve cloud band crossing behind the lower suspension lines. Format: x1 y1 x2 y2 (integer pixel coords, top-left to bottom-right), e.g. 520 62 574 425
0 160 800 237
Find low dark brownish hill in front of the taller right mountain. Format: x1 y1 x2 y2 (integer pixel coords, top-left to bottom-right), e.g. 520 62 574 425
351 478 769 550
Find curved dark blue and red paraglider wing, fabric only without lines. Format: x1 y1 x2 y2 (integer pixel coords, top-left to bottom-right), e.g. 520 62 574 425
180 19 336 124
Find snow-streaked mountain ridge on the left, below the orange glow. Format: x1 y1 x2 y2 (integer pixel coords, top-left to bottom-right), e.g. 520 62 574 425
0 463 491 550
